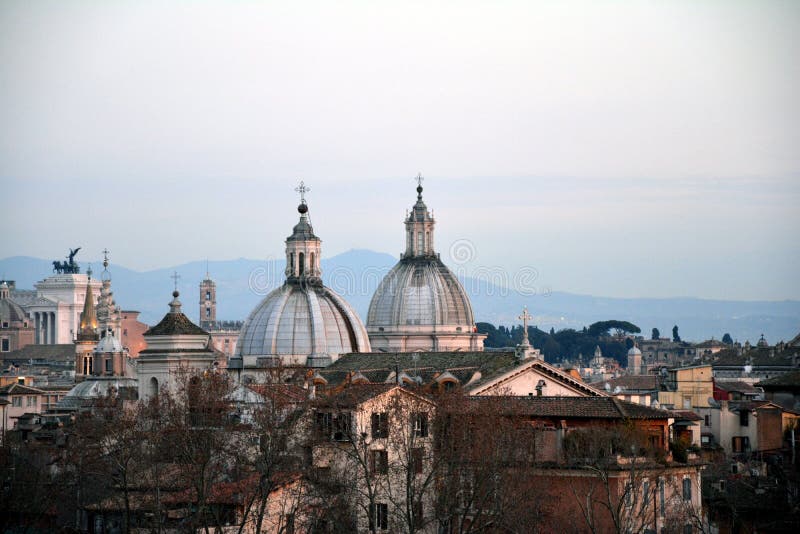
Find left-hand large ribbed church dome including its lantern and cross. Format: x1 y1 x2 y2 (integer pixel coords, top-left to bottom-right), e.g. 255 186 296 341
229 182 370 369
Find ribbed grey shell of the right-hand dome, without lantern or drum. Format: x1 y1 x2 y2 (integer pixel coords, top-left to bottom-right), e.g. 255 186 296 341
367 257 475 332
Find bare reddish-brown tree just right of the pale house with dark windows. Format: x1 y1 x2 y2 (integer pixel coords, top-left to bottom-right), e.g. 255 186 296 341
435 394 553 534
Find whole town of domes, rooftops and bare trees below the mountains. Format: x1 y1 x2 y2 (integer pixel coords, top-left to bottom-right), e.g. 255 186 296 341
0 183 800 534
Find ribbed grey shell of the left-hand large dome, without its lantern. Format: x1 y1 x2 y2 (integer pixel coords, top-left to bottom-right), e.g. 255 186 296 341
231 282 370 365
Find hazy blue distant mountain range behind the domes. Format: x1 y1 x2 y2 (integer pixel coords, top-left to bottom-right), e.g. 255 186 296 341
0 250 800 343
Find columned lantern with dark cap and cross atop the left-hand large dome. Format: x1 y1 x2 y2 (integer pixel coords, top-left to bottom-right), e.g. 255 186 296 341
285 181 322 284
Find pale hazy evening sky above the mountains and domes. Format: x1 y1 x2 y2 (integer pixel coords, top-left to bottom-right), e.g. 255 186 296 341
0 0 800 300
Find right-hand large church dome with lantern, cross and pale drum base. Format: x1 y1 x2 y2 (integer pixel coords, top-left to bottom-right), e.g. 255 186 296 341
367 177 486 352
